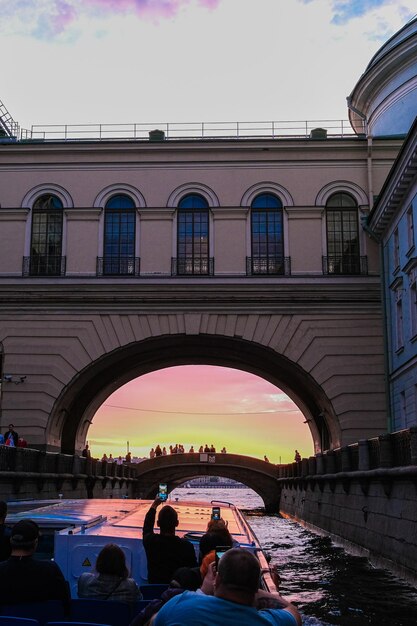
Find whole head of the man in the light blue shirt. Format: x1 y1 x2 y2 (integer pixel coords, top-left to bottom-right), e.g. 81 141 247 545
214 548 261 605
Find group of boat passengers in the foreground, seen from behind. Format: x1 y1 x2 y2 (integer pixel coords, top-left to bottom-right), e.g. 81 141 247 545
0 498 301 626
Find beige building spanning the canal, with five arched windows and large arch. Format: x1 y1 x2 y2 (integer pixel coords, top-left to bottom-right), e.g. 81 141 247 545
0 15 414 452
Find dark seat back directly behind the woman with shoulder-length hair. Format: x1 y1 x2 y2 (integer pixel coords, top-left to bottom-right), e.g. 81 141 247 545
71 598 131 626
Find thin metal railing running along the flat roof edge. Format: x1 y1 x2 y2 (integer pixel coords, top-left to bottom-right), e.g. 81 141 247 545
20 120 355 141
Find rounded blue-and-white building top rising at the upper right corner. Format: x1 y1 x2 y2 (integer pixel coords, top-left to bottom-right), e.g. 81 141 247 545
347 16 417 137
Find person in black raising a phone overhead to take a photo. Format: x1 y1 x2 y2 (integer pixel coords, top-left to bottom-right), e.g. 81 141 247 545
143 498 197 584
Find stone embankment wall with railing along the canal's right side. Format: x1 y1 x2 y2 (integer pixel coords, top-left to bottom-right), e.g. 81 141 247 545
279 428 417 585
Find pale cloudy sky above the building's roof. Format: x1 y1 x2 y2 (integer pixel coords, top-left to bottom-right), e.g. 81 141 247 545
0 0 417 128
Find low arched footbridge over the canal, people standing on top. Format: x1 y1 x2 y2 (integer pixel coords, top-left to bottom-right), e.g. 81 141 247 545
137 453 280 513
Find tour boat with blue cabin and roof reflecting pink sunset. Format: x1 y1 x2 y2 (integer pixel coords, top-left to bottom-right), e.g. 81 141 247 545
7 499 275 598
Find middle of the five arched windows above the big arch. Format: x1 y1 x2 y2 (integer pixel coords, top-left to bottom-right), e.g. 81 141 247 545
173 194 212 275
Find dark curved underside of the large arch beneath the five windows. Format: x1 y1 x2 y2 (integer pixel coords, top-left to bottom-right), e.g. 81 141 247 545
46 334 341 453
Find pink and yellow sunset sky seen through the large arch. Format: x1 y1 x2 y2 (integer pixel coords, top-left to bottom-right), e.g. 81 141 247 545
87 365 313 463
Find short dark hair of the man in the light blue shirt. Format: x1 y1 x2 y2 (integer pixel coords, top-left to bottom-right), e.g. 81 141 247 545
218 548 261 595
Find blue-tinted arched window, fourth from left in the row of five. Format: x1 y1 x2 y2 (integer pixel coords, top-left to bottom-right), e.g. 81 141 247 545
248 193 285 274
